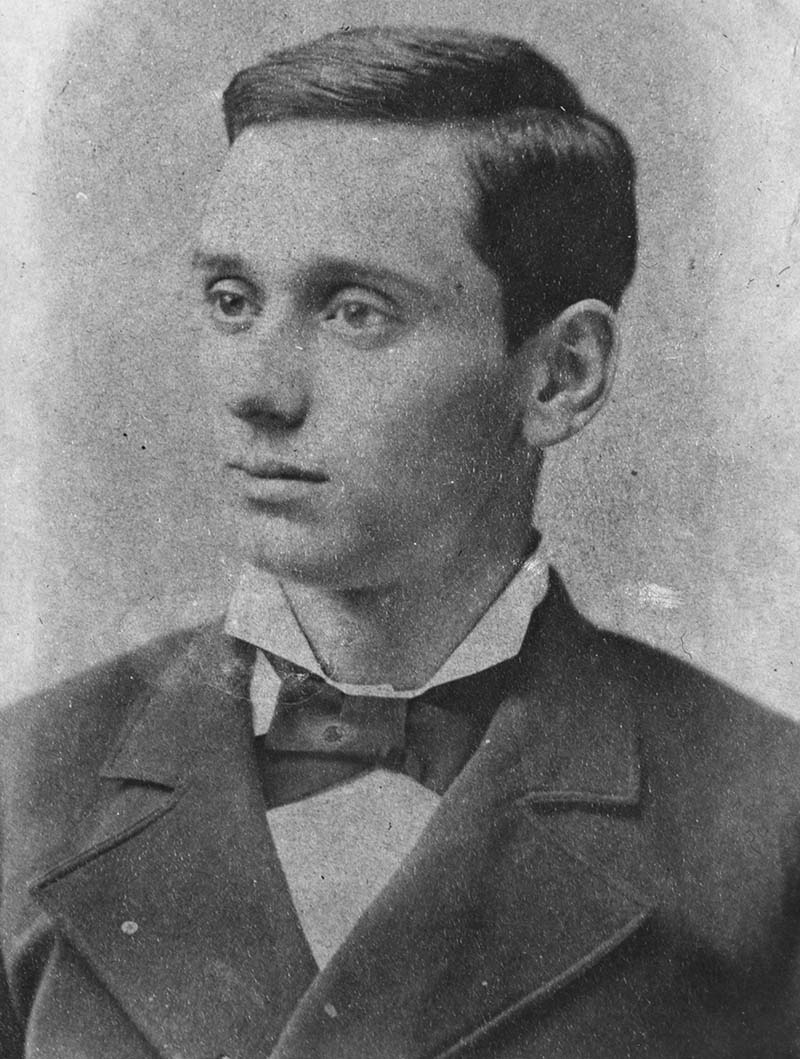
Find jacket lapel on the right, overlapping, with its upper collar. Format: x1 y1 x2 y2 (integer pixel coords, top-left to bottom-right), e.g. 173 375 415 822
273 582 652 1059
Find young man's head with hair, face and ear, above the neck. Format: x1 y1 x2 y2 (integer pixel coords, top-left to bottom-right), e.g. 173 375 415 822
196 30 636 589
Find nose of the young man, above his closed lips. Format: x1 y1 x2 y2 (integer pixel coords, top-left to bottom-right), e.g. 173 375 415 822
225 313 310 431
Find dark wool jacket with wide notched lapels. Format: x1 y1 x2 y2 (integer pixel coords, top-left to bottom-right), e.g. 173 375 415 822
0 580 800 1059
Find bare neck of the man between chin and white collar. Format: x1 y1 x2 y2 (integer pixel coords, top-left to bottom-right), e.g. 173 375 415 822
282 519 531 689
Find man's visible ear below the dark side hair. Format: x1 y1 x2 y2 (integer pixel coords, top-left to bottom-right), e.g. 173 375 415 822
516 299 619 448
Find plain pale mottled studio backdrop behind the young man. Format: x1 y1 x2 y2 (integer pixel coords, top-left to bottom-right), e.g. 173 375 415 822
0 0 800 716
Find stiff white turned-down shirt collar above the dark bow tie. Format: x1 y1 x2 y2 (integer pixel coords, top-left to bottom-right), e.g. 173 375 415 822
225 544 548 735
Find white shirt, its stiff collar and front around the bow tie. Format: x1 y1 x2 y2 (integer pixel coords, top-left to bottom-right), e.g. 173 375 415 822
226 546 549 969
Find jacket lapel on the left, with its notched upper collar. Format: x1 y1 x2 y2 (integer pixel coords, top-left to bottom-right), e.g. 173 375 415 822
33 627 316 1059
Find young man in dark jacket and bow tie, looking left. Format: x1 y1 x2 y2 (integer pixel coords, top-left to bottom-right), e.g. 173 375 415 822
0 29 800 1059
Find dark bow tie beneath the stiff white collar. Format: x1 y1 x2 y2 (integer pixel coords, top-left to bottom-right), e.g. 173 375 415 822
256 656 502 808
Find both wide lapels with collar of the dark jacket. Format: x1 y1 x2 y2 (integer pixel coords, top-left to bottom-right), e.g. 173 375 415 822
35 577 651 1059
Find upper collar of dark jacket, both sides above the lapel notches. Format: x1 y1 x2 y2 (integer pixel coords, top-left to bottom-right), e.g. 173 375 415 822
102 571 640 806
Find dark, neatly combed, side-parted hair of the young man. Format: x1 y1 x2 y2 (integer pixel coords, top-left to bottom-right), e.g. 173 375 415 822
224 26 637 346
